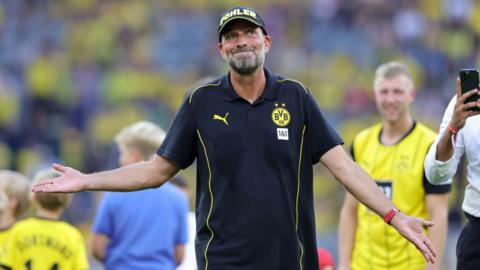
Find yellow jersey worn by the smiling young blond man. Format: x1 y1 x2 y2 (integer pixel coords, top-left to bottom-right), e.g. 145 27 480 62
352 123 436 270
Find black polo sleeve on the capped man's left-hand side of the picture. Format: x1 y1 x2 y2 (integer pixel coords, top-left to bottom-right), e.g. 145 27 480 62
157 98 196 169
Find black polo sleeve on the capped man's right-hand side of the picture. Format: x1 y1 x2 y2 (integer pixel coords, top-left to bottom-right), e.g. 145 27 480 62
304 93 343 164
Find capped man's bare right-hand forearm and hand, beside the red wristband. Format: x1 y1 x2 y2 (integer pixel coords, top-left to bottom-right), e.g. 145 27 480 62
320 145 436 263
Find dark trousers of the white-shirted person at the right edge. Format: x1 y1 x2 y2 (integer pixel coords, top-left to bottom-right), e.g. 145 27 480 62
457 213 480 270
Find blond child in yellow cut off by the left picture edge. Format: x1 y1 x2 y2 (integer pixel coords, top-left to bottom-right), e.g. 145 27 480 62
0 170 30 269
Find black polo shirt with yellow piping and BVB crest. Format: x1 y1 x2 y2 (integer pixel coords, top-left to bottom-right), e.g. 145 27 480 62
157 70 343 270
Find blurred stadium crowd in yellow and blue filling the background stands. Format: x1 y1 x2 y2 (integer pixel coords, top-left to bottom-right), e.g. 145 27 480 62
0 0 474 260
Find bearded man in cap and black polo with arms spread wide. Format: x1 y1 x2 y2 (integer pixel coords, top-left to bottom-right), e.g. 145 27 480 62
33 7 435 270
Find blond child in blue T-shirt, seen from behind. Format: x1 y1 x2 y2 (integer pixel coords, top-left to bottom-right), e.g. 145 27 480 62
92 121 188 270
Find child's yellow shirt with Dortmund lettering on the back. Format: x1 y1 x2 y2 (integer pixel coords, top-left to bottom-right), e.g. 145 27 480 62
3 217 89 270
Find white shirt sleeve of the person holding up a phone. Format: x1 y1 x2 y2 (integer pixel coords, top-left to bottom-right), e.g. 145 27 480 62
424 96 464 185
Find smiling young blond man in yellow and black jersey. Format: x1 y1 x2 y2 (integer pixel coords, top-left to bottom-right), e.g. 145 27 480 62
339 62 450 270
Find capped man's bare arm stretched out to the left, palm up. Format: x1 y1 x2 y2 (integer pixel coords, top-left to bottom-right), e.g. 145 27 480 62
32 155 180 193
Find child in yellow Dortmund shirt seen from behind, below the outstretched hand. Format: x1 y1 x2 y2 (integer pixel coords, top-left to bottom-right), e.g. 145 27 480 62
2 170 89 270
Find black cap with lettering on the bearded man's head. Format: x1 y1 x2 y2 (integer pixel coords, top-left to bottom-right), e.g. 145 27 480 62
218 7 267 41
